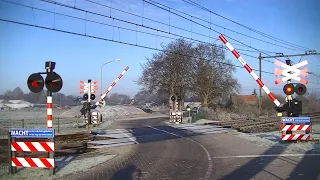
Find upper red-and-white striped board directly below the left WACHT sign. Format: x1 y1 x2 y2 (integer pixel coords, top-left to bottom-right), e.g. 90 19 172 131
11 142 54 152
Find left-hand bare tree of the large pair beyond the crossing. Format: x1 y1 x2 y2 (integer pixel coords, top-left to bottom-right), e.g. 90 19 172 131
138 39 193 102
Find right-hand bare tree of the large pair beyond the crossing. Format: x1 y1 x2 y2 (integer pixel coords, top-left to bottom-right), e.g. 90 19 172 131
192 44 240 107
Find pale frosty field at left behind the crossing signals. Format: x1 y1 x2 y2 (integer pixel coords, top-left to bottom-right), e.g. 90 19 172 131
0 106 146 136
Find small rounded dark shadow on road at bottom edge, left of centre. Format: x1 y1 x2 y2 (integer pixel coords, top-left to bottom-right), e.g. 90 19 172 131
110 165 141 180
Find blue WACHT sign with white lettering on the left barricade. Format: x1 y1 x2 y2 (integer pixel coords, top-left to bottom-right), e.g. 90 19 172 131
9 128 54 138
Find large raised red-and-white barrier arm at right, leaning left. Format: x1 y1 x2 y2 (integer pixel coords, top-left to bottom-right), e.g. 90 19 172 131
219 34 280 107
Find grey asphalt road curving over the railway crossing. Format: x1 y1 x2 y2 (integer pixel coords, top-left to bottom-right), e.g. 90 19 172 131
63 118 320 180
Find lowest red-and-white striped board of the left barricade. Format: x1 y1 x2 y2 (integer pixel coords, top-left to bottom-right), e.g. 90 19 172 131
11 157 54 168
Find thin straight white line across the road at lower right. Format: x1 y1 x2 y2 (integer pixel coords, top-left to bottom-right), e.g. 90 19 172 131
212 154 320 159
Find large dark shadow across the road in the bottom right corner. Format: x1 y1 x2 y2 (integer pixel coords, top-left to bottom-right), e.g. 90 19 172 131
221 143 320 180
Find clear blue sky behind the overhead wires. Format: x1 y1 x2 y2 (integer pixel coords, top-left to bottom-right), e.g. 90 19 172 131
0 0 320 96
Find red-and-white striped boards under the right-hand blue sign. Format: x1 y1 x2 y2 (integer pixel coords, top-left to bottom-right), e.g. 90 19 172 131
280 124 311 141
